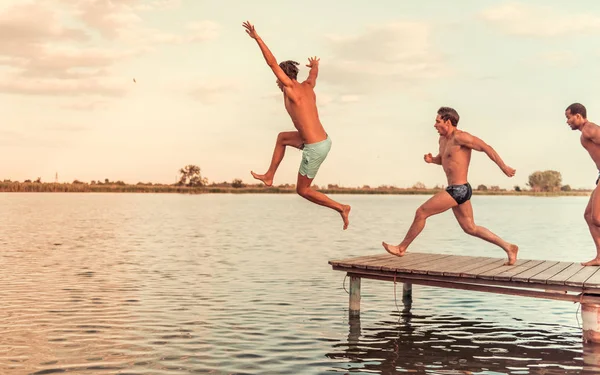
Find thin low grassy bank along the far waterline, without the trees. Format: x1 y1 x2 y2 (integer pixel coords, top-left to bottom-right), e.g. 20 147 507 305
0 181 591 196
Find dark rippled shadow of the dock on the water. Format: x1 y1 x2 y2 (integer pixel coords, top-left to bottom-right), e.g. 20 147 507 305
326 298 600 374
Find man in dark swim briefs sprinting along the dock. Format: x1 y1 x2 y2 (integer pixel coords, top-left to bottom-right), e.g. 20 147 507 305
382 107 519 265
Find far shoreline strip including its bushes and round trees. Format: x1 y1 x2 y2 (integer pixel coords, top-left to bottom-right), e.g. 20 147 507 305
0 164 592 197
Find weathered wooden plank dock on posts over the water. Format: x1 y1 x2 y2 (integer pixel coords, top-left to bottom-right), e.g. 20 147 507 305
329 252 600 342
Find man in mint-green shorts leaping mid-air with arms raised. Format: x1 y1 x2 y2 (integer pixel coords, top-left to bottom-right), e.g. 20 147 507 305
243 22 351 230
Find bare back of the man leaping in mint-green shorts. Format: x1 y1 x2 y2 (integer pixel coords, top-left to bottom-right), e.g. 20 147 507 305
283 82 327 144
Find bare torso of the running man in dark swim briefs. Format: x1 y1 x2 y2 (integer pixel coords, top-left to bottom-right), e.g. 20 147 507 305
439 130 471 185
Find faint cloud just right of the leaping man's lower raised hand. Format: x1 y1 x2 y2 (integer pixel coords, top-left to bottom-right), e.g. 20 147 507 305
321 21 449 93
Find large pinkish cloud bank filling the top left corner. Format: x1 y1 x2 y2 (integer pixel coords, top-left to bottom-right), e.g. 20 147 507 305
0 0 219 98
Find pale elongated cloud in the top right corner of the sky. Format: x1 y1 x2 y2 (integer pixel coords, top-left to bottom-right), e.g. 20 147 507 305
479 3 600 37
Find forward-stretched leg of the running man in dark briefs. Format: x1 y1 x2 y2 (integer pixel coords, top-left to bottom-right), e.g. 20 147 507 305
381 191 457 256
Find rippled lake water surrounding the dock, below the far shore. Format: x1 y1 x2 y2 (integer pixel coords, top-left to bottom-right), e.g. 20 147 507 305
0 193 600 375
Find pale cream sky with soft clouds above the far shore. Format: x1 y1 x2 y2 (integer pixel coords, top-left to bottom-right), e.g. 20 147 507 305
0 0 600 189
